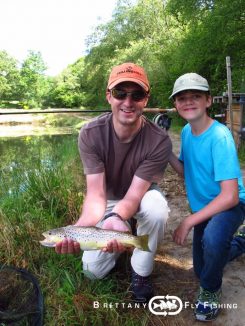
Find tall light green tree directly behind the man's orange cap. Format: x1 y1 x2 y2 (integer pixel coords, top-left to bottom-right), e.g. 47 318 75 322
84 0 178 106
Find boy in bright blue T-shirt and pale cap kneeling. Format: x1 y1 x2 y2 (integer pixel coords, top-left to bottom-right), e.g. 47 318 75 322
170 73 245 321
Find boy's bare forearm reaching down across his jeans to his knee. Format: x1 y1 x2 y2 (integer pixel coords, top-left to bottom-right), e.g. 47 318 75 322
173 179 239 245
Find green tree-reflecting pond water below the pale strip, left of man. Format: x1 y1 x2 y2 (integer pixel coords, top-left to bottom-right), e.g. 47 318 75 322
0 132 79 196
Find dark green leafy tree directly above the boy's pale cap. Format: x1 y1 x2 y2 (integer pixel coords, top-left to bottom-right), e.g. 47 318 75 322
167 0 245 94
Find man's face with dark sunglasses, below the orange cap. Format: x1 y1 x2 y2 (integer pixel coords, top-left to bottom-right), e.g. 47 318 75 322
106 82 148 126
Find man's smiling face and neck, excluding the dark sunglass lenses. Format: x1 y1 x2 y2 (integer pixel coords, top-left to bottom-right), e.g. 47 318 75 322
106 82 149 129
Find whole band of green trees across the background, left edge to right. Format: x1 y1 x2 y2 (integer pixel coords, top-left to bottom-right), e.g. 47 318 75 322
0 0 245 108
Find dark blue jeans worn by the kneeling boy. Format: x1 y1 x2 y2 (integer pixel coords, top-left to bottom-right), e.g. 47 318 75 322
193 203 245 292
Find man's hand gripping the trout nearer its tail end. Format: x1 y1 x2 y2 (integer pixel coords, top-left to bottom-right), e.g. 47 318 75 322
102 216 130 253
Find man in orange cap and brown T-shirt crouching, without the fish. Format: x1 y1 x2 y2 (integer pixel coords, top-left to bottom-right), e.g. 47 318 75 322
56 63 172 302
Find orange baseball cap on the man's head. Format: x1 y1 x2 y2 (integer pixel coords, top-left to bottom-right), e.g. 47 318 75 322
107 62 150 92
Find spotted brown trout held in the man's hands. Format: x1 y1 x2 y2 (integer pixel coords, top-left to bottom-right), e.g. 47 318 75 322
40 225 150 251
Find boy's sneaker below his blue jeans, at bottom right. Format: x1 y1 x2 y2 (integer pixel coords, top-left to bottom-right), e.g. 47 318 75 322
194 287 221 321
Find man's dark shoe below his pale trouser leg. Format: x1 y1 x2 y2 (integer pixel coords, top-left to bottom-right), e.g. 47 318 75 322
130 269 154 303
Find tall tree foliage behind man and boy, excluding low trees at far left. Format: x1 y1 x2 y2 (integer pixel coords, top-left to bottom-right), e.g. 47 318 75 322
79 0 245 107
